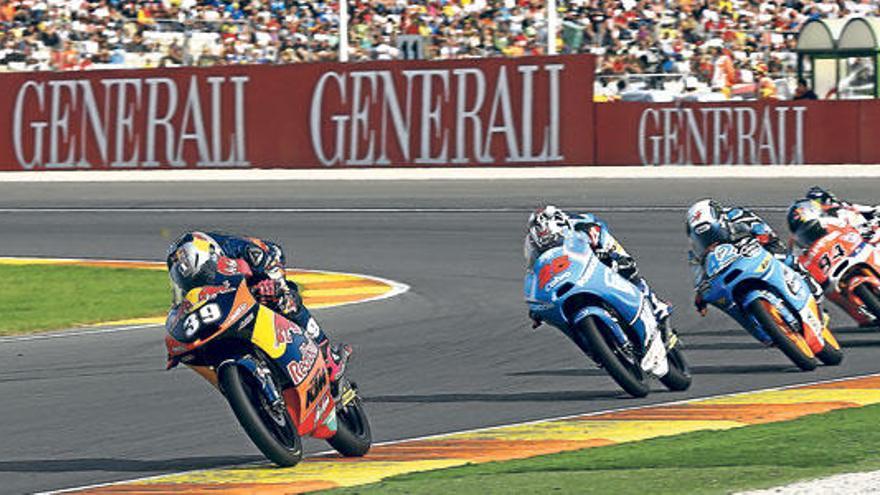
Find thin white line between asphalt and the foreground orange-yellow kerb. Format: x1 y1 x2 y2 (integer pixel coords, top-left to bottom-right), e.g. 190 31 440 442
34 373 880 495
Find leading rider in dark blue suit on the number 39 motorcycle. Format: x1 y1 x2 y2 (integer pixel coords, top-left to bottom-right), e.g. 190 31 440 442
166 231 351 381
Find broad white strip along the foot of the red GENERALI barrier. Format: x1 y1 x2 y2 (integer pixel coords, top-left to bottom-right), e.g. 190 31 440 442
0 165 880 182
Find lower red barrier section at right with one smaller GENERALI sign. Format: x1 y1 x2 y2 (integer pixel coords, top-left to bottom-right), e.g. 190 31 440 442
595 101 868 165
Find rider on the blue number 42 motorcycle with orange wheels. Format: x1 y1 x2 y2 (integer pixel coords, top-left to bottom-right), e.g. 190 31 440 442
685 199 828 318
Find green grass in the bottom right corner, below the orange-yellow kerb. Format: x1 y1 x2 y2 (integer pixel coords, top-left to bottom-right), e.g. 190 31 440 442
329 405 880 495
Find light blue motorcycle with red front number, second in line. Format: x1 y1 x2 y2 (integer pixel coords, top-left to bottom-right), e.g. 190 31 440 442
524 232 691 397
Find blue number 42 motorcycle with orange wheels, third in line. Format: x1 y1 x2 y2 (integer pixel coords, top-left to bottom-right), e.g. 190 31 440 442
698 238 843 371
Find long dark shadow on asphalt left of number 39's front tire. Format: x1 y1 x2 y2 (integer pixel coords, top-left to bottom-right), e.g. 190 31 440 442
0 455 264 473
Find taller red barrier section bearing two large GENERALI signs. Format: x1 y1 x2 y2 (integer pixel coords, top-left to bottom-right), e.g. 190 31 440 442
0 55 595 170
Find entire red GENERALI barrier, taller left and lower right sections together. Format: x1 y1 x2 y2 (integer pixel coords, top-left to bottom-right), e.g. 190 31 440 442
0 55 880 170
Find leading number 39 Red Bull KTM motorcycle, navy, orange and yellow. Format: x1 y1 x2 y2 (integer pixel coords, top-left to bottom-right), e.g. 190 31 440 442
165 258 372 467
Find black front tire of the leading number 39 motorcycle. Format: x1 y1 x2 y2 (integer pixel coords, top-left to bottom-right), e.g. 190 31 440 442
217 364 303 467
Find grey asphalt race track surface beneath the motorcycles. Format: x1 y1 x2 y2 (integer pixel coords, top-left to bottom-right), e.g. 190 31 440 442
0 178 880 493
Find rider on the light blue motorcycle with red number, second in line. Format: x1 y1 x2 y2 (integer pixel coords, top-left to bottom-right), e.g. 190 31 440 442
525 205 672 340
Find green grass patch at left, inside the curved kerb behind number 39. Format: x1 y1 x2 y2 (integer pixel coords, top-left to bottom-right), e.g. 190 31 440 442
0 265 171 335
